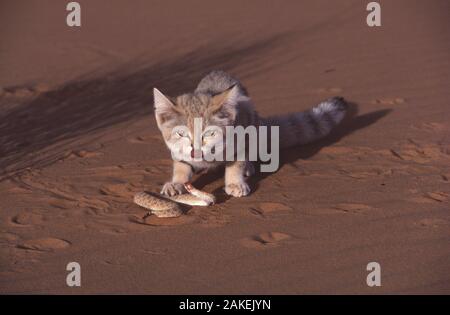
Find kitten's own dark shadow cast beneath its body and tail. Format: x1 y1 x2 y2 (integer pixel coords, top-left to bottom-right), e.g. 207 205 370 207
193 102 392 203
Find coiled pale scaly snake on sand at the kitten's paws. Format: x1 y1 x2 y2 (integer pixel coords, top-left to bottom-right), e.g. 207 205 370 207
134 183 216 218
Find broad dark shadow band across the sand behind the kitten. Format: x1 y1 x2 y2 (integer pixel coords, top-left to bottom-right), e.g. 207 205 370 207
0 33 298 180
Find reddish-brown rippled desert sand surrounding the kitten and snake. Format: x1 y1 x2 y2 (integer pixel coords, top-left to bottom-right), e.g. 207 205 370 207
0 0 450 294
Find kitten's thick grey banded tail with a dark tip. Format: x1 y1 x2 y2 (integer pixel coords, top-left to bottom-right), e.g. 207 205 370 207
262 97 348 149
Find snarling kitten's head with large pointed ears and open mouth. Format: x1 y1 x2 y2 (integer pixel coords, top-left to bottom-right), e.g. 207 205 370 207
153 86 247 161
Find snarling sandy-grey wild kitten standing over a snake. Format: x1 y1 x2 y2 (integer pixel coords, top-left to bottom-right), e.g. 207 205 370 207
154 71 347 197
